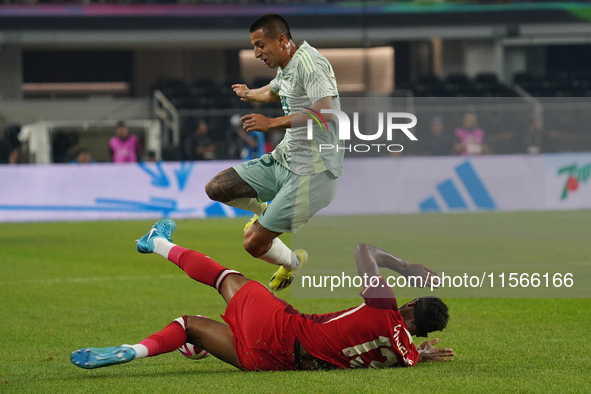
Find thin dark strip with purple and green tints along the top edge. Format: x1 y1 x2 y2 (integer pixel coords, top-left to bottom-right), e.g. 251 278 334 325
0 1 591 30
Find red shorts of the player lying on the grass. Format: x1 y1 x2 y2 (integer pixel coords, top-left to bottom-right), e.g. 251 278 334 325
222 281 295 371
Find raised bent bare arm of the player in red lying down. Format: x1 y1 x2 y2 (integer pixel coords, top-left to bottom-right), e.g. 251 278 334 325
355 244 438 288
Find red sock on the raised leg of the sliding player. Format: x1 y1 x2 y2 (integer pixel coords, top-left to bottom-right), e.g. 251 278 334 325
168 246 242 291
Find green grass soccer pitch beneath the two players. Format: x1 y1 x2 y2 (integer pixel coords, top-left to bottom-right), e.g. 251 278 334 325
0 211 591 393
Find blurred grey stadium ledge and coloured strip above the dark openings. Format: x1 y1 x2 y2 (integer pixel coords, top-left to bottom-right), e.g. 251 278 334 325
0 1 591 47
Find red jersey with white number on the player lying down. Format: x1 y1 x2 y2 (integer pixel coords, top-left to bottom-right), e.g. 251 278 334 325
286 277 419 368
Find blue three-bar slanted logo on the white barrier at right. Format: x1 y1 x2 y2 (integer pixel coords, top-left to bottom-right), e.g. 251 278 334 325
419 161 497 212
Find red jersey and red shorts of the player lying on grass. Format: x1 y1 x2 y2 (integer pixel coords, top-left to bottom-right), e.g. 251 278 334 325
222 277 419 371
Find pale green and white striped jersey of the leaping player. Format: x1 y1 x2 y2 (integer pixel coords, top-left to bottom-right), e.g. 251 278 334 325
269 41 344 177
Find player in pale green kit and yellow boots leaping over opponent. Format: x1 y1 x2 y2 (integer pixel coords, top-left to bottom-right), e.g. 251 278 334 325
205 14 344 290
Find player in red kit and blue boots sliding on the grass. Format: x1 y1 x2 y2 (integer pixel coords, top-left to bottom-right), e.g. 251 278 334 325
71 219 454 371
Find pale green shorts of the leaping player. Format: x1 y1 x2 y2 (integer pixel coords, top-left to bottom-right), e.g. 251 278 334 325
234 153 339 233
